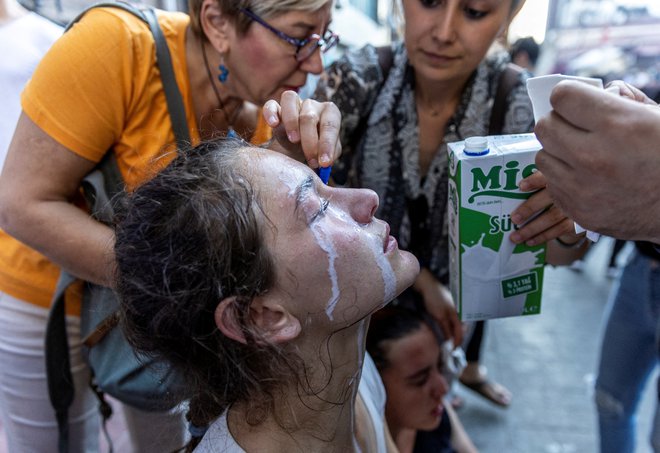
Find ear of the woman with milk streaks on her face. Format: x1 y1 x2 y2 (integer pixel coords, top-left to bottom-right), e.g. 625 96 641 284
215 294 301 344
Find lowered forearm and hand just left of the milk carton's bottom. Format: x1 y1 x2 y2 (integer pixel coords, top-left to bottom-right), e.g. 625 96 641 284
413 268 463 347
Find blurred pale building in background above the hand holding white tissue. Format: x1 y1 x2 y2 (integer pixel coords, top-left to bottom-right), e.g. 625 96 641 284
537 0 660 98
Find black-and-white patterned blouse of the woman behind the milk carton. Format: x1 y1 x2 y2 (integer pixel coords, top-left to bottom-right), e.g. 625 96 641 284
314 43 534 290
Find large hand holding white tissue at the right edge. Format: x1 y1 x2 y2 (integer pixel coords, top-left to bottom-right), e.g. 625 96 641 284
535 81 660 243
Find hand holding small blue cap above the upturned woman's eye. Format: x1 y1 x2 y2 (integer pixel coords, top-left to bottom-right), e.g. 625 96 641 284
263 91 341 168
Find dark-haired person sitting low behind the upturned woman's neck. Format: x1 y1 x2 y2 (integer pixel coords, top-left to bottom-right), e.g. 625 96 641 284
367 306 477 453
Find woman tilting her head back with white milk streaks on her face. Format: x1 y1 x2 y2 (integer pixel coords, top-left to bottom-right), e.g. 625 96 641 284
116 140 419 451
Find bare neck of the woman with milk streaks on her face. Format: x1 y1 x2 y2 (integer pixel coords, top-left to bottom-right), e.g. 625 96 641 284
228 321 366 453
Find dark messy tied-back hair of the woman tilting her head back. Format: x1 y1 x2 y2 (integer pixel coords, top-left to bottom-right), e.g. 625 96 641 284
115 139 301 448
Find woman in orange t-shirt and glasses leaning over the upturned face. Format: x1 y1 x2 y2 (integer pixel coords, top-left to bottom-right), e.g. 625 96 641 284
0 0 341 446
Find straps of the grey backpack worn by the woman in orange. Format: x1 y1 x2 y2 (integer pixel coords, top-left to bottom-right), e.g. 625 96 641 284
45 2 190 453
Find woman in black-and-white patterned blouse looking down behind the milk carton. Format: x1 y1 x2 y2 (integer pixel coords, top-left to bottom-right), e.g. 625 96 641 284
315 0 586 405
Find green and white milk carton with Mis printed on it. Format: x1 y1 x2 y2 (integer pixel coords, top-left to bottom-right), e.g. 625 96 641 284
448 134 545 321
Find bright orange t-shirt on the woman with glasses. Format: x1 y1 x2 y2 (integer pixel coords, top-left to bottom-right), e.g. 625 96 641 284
0 8 271 314
